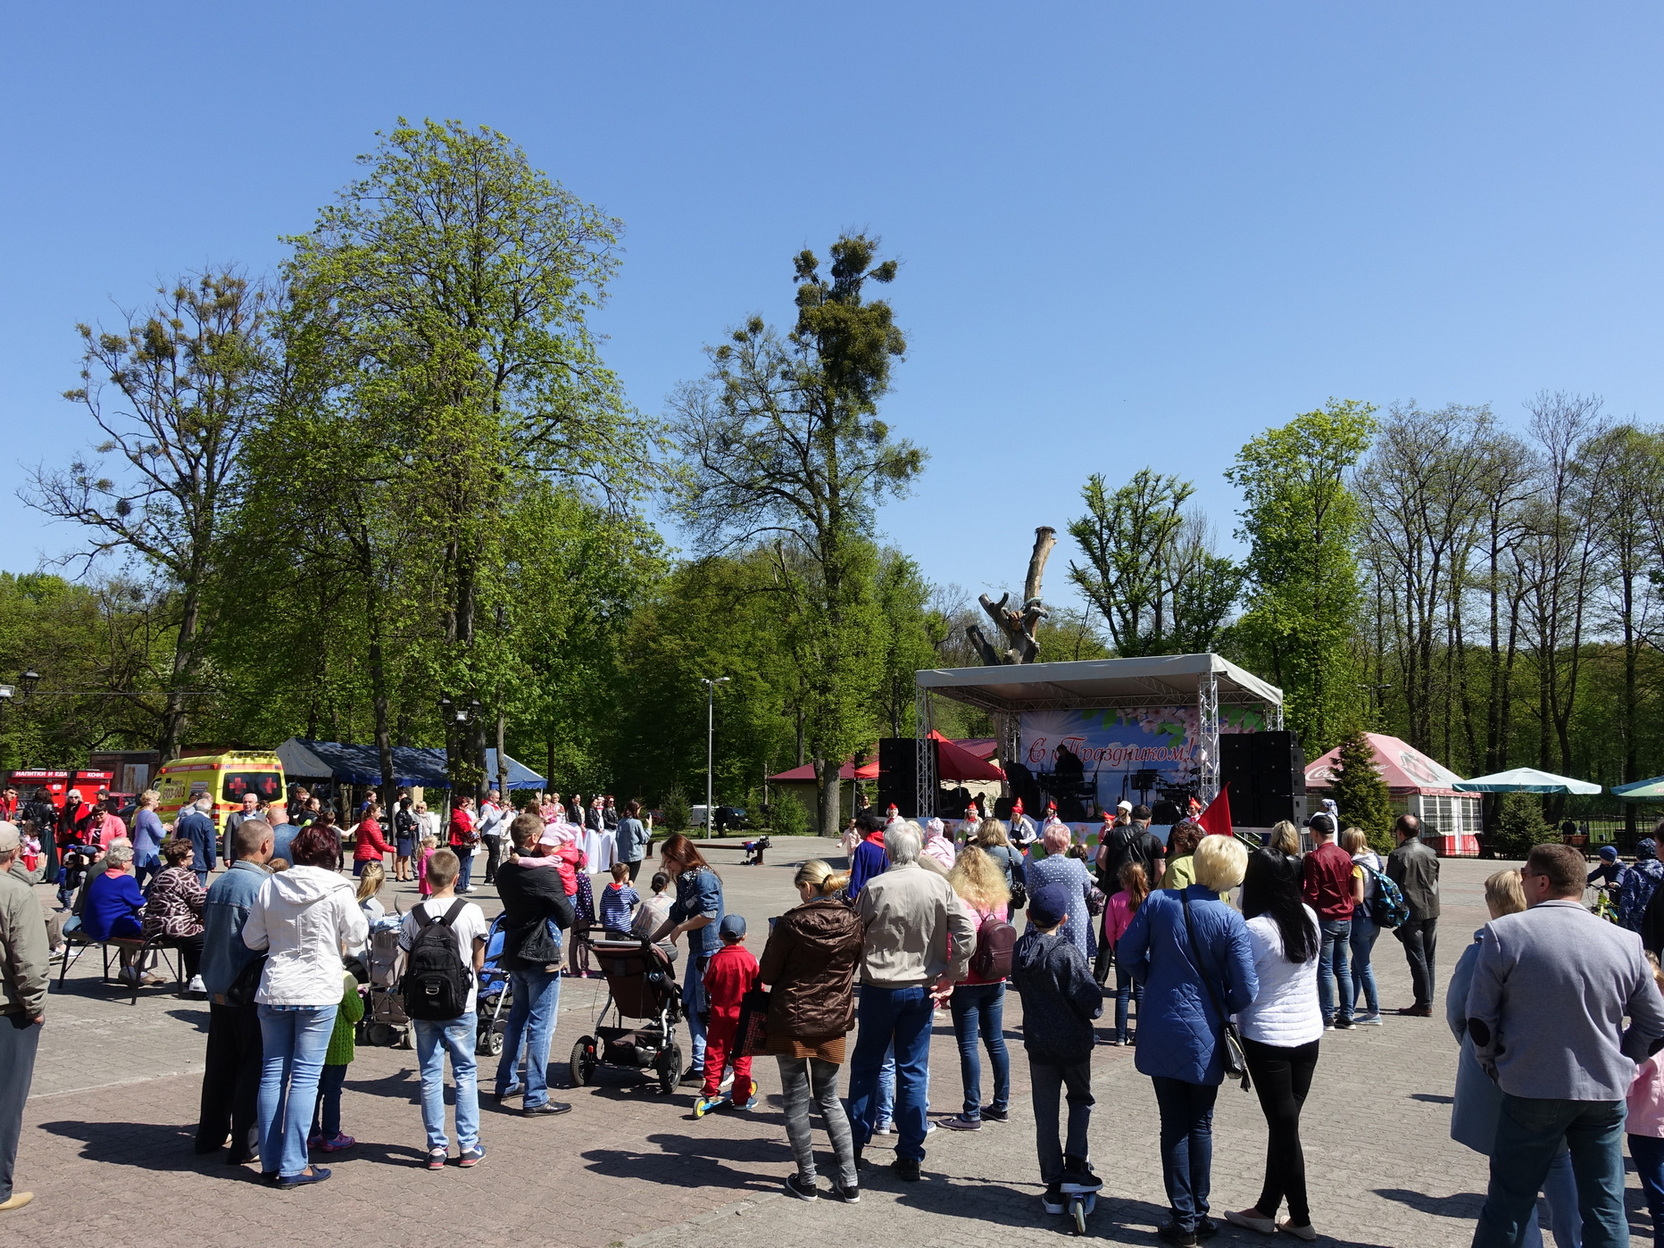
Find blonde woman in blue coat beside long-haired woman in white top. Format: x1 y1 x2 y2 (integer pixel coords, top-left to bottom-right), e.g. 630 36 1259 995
1115 835 1260 1248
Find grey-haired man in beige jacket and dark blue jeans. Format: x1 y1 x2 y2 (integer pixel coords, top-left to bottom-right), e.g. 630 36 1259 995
849 822 977 1183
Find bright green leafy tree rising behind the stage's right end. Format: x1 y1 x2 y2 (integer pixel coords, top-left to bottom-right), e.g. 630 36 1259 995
1225 399 1376 757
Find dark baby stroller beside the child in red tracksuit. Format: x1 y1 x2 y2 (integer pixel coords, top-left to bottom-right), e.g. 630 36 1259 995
569 940 682 1093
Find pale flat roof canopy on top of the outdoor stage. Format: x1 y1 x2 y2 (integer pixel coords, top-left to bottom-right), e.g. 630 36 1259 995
915 654 1283 712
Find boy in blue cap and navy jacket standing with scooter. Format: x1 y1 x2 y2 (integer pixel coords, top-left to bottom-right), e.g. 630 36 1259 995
1012 884 1103 1213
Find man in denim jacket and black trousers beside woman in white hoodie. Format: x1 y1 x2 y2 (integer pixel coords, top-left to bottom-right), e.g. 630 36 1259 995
196 819 271 1165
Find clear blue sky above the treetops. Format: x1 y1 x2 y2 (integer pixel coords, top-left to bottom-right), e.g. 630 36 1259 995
0 0 1664 612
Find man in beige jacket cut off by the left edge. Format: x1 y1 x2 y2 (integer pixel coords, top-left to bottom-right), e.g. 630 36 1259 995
0 824 47 1213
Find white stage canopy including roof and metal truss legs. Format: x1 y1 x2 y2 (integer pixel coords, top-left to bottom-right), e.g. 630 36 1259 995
914 654 1283 822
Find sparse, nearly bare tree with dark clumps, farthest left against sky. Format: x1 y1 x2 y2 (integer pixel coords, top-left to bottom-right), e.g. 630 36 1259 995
23 270 273 757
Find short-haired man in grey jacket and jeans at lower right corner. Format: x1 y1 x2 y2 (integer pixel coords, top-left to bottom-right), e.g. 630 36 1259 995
1468 845 1664 1248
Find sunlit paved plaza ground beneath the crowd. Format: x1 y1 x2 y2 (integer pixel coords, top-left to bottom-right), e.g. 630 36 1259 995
0 839 1651 1248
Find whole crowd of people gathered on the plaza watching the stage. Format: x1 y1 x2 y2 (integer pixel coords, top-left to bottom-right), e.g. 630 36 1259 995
0 792 1664 1248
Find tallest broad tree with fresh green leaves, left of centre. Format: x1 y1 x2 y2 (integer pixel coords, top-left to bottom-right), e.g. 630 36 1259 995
285 120 651 787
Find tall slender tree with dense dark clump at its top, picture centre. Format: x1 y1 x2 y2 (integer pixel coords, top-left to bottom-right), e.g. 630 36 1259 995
674 235 925 835
